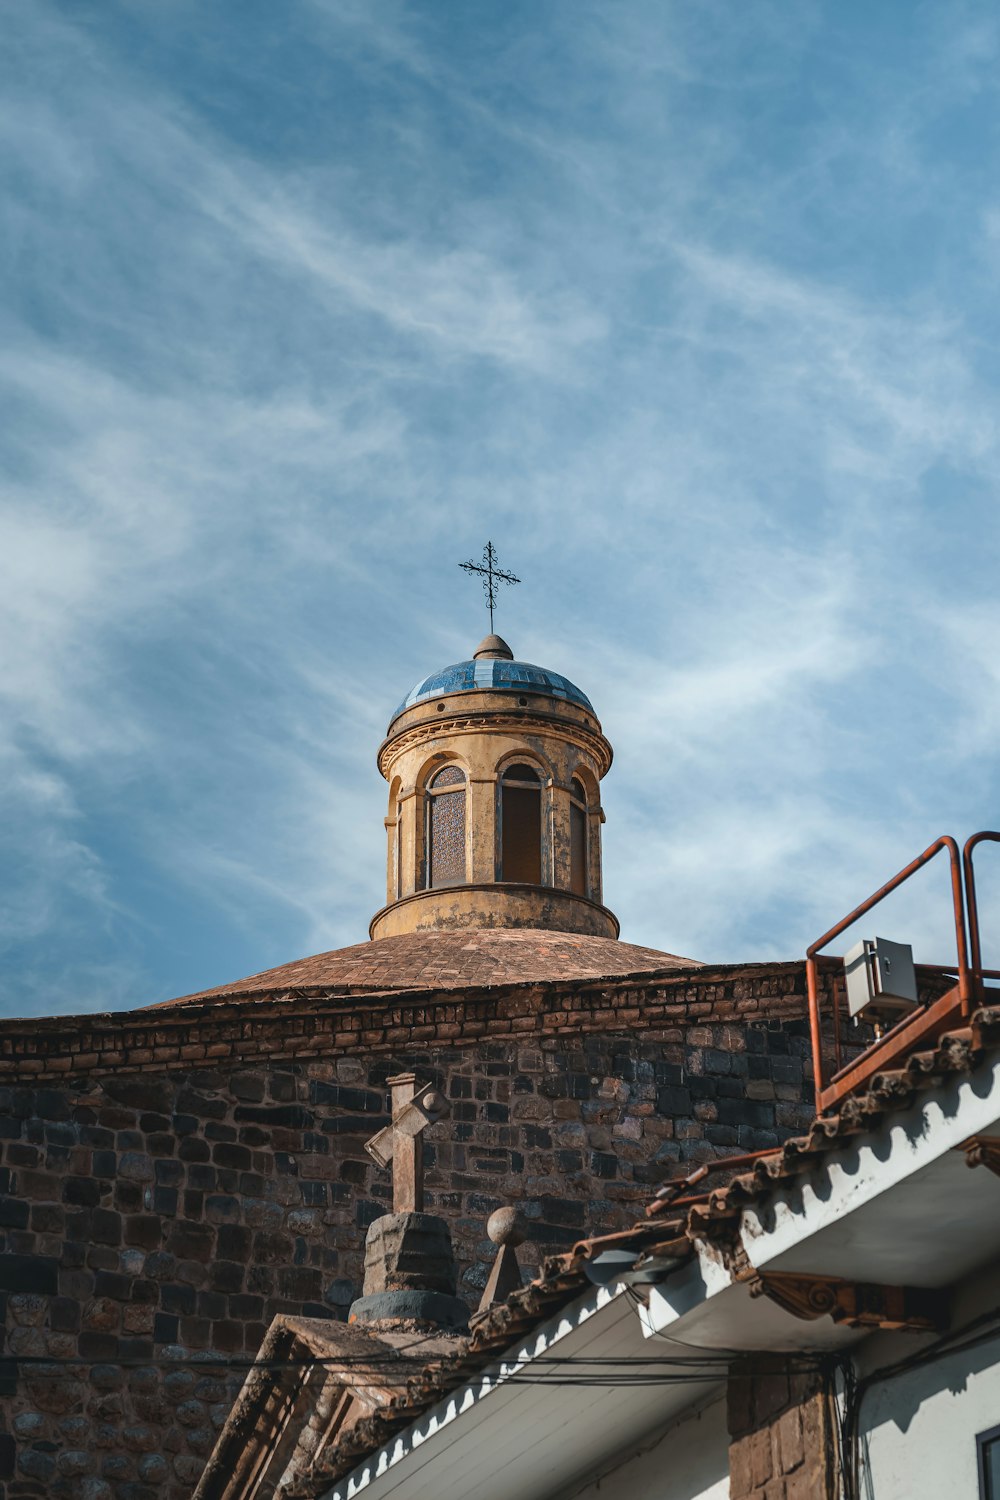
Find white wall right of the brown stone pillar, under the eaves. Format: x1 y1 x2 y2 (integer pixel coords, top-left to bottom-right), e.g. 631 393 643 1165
858 1275 1000 1500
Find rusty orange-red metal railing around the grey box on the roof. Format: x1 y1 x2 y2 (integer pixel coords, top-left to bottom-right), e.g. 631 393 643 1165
805 831 1000 1112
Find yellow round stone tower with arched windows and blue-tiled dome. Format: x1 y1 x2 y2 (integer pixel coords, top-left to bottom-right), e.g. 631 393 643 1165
369 635 619 938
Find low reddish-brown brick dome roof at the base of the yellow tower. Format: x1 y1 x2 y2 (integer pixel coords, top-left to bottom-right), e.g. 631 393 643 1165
162 929 700 1005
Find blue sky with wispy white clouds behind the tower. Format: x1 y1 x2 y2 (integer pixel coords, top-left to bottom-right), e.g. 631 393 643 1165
0 0 1000 1016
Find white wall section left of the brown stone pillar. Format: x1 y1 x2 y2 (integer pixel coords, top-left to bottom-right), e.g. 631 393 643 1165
553 1397 729 1500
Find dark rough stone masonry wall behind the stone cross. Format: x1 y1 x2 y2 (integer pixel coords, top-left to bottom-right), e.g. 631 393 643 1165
0 966 813 1500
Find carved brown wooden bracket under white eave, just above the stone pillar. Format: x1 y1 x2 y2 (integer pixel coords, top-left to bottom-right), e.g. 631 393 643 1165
750 1271 948 1332
